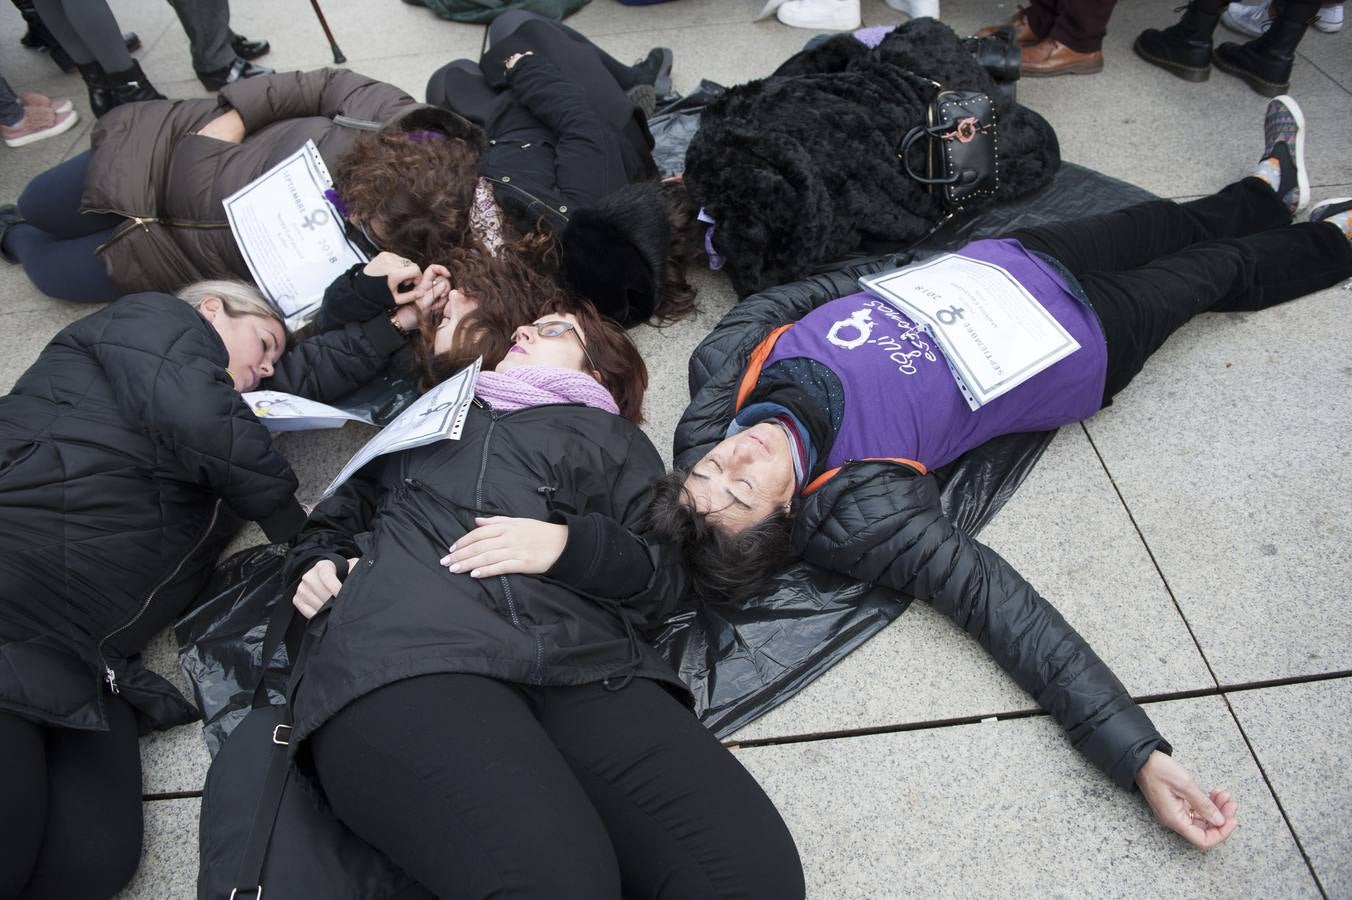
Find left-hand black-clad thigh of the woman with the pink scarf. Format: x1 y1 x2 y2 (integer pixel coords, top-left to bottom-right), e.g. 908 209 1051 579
308 674 619 900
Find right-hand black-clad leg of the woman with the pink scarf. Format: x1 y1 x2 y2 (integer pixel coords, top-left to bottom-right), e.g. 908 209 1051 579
533 678 804 900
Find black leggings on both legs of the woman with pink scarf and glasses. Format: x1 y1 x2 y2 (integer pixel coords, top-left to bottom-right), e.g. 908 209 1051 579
310 674 803 900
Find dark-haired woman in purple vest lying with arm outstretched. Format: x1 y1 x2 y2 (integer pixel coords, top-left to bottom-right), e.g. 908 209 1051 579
649 97 1352 847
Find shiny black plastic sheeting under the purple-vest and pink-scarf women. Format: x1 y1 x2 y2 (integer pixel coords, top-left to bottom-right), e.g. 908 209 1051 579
176 165 1152 740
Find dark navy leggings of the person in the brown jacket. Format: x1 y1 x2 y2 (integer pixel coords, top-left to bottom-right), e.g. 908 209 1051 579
4 150 126 303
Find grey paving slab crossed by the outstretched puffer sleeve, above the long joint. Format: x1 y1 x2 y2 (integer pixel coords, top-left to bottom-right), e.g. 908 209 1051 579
733 427 1214 741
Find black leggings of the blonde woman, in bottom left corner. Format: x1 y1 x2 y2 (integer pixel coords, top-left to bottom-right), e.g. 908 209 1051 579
0 695 141 900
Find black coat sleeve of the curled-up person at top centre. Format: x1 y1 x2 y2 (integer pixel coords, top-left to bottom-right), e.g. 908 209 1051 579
507 55 629 207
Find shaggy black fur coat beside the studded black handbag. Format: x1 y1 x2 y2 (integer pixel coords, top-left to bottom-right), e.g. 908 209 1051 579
685 19 1060 296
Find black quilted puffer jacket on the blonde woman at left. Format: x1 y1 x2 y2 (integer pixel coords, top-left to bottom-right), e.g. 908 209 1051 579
0 293 403 728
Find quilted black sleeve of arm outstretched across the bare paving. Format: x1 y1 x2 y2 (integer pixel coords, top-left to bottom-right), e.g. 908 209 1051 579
794 464 1169 788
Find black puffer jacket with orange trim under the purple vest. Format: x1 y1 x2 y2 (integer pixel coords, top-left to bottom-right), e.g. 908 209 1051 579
675 264 1169 788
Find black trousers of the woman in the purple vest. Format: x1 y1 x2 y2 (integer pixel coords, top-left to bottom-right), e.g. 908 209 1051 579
1006 178 1352 405
